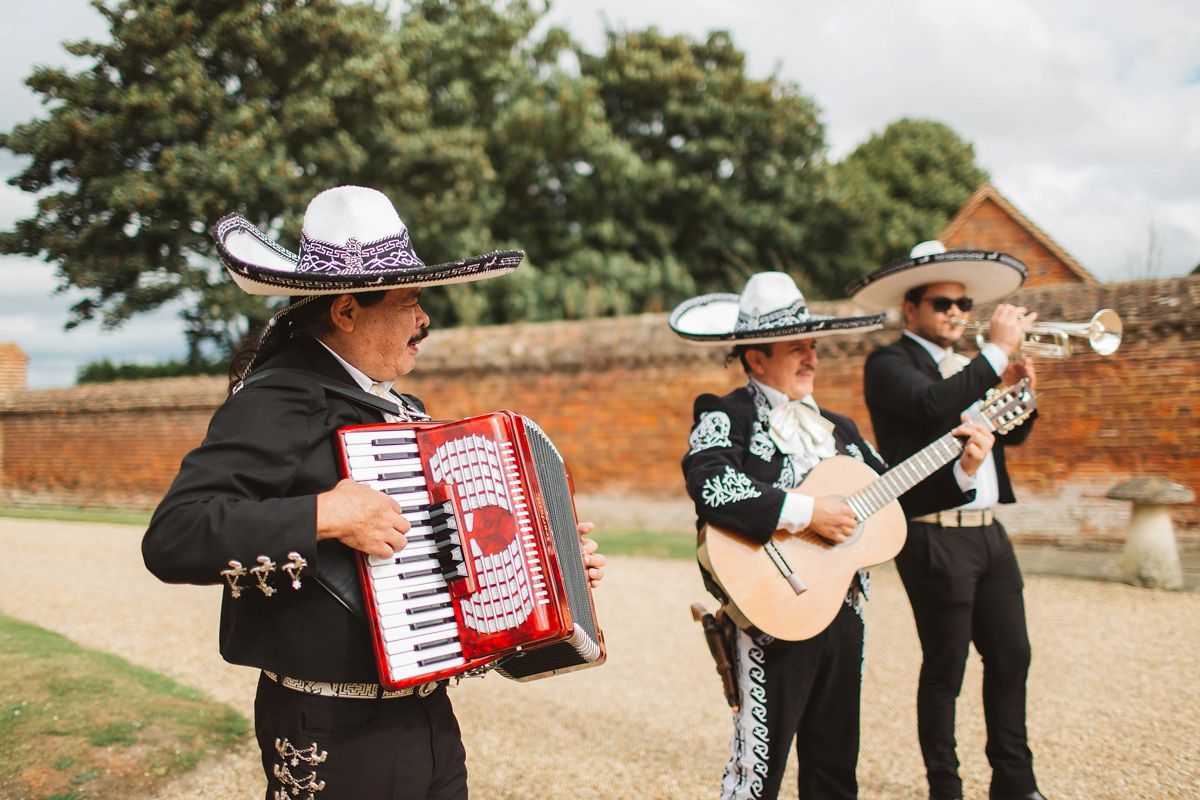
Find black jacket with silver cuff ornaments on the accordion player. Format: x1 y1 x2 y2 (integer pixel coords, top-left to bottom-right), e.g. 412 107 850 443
142 339 412 682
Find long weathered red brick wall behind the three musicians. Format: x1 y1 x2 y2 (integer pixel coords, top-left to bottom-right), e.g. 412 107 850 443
0 277 1200 551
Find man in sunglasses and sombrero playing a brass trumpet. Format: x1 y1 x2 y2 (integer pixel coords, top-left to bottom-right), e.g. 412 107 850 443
846 242 1044 800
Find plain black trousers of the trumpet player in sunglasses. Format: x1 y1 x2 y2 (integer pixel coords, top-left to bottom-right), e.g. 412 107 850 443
895 522 1037 798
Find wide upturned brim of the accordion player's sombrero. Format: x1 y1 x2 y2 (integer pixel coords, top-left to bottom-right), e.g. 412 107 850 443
214 213 524 296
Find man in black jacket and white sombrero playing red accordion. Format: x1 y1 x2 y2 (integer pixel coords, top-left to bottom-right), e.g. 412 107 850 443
143 186 605 800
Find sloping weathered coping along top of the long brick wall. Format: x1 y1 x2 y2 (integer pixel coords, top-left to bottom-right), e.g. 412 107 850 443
0 276 1200 414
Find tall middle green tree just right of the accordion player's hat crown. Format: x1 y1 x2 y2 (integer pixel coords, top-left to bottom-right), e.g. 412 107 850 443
398 0 690 323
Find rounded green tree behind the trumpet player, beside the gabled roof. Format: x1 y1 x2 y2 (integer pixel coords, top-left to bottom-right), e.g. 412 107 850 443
816 119 988 285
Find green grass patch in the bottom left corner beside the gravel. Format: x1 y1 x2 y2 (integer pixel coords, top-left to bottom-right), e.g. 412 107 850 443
0 615 250 800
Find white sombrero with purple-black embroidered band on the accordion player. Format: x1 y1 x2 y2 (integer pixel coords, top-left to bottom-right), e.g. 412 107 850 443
214 186 524 296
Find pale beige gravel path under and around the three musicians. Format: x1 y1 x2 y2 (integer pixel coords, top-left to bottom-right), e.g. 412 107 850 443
0 519 1200 800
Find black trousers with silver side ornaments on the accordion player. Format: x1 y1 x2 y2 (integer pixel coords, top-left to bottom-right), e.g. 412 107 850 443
254 675 467 800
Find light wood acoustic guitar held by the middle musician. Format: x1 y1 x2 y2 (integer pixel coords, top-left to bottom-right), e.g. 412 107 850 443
698 380 1037 640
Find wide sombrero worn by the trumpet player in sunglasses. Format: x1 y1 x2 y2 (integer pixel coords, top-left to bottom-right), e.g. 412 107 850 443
846 241 1030 308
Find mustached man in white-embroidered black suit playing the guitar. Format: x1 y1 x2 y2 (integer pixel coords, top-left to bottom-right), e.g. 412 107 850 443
671 272 992 800
